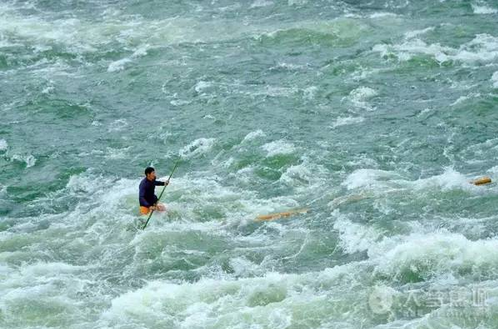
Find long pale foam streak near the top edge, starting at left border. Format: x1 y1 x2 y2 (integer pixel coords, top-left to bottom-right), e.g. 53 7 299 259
0 6 366 62
